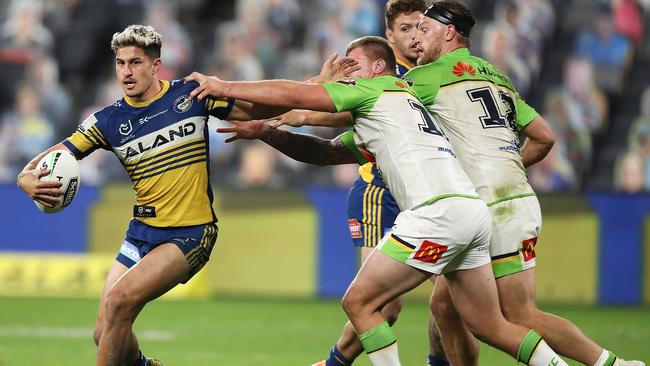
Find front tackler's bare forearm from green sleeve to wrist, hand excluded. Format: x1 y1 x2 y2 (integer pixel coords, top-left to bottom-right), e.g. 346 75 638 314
222 80 336 112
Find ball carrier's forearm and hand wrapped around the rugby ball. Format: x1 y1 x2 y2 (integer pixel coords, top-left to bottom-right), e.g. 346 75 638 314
16 144 68 207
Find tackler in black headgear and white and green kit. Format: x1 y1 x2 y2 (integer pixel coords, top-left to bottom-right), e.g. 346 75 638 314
405 0 643 366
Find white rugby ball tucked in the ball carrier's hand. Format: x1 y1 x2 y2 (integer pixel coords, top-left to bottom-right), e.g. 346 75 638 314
34 150 81 213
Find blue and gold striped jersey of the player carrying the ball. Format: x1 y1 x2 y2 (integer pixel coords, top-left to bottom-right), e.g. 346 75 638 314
63 80 234 227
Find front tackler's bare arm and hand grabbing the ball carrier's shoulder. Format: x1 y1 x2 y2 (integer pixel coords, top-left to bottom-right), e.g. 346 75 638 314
185 72 337 112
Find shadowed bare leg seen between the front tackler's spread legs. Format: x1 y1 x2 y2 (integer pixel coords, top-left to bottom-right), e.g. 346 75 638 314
429 276 479 366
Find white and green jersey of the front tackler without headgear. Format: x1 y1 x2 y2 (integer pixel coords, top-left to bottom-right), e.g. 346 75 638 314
323 76 478 211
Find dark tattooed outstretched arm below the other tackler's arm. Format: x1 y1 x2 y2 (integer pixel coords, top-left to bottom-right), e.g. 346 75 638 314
217 120 358 166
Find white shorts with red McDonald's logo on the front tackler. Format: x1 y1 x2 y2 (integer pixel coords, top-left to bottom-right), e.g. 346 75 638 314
378 197 492 274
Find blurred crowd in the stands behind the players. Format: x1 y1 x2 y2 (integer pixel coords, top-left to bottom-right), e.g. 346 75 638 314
0 0 650 193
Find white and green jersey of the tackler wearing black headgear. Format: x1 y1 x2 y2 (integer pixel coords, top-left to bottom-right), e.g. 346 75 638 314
405 48 538 205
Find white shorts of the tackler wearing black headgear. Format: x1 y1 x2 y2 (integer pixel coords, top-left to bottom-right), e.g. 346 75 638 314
490 196 542 278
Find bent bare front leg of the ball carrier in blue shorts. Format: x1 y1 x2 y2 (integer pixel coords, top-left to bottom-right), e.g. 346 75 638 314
97 244 188 366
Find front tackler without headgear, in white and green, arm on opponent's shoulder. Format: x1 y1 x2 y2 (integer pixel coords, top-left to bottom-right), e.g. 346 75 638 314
186 37 566 366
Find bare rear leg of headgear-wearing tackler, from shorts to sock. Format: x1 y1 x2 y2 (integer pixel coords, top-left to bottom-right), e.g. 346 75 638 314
496 268 603 365
